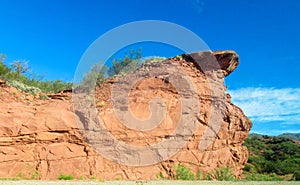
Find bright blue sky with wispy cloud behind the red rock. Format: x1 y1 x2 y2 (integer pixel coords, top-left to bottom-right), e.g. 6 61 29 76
0 0 300 135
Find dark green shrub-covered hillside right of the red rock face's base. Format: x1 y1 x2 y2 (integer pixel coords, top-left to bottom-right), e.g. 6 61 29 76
244 135 300 181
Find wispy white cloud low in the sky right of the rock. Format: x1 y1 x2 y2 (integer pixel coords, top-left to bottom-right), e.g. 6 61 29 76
228 87 300 125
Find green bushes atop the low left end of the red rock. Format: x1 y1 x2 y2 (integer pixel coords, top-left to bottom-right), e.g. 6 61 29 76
0 54 72 95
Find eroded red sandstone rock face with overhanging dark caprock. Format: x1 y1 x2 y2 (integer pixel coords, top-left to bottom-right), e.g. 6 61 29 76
0 51 252 180
